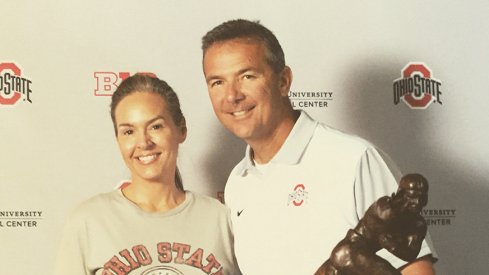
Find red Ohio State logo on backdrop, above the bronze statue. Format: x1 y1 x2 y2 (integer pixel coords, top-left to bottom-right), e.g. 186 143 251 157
393 62 442 109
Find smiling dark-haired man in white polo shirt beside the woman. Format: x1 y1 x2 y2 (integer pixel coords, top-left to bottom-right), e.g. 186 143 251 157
202 20 433 275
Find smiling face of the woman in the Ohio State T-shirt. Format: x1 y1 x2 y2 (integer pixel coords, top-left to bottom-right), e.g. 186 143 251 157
115 92 186 182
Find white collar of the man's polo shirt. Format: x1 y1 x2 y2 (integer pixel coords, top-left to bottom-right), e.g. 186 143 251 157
236 110 318 175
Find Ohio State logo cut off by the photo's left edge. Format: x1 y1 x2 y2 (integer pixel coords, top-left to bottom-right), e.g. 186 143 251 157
0 62 32 106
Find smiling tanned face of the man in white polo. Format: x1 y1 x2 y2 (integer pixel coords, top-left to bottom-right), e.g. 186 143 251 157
203 39 291 142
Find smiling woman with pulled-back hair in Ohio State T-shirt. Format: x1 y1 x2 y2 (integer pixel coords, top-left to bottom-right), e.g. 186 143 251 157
55 75 240 275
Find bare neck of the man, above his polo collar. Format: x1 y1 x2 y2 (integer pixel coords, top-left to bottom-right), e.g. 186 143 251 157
247 110 300 164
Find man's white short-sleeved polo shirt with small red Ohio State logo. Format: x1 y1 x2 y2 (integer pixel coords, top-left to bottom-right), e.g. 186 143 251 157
225 112 432 275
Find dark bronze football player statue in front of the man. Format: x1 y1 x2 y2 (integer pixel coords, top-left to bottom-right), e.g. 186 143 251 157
315 174 428 275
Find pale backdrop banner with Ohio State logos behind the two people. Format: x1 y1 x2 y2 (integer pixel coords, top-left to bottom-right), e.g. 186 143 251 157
0 0 489 275
